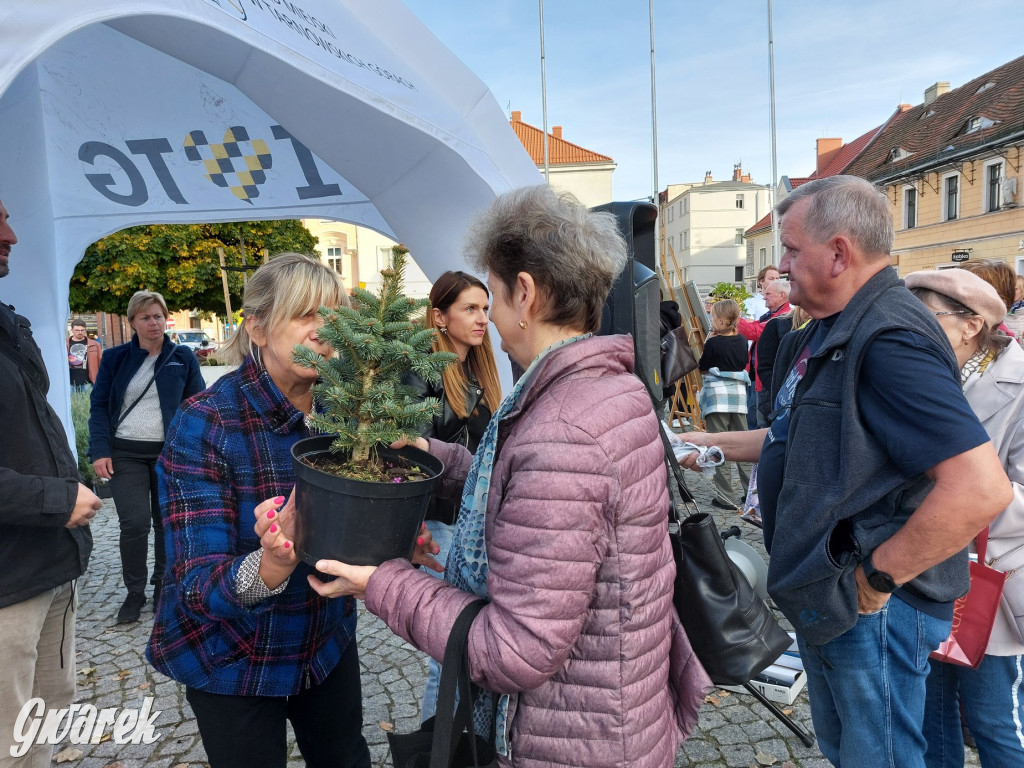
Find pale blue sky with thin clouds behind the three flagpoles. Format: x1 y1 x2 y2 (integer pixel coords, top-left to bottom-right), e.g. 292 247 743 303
406 0 1024 200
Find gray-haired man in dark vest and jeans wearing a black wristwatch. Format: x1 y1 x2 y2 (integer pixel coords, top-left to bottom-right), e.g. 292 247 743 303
687 176 1013 768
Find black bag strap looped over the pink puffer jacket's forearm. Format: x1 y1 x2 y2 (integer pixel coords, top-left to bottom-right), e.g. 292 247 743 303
430 600 487 768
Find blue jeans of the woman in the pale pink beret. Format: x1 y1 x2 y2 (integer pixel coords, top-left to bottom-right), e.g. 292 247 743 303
925 655 1024 768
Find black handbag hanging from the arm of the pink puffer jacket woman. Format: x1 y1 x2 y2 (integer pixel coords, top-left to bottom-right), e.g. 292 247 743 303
387 600 498 768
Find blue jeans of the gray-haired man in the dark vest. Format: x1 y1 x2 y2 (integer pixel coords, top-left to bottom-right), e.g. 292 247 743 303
798 597 952 768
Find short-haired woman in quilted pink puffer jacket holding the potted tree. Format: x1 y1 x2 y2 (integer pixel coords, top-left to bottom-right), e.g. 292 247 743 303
310 186 711 768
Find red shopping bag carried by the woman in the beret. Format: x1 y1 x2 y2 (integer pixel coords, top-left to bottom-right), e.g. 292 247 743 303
931 527 1007 670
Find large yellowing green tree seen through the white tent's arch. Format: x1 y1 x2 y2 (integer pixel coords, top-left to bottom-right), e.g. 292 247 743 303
71 221 317 314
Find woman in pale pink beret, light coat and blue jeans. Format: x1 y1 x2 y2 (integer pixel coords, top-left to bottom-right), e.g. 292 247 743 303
906 269 1024 768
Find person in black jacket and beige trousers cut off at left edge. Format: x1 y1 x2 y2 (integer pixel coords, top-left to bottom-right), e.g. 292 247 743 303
0 196 99 767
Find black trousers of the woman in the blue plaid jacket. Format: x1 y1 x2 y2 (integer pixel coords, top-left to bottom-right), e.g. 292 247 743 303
185 640 370 768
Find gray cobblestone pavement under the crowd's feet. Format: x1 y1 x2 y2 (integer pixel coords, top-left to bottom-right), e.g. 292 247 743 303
54 460 978 768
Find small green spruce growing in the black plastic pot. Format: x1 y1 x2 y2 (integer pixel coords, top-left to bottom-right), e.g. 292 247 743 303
295 245 459 476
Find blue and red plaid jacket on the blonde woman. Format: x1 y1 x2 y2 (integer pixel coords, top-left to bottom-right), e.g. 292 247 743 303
146 357 355 696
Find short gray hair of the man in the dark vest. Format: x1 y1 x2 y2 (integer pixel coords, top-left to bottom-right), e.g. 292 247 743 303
775 176 895 256
